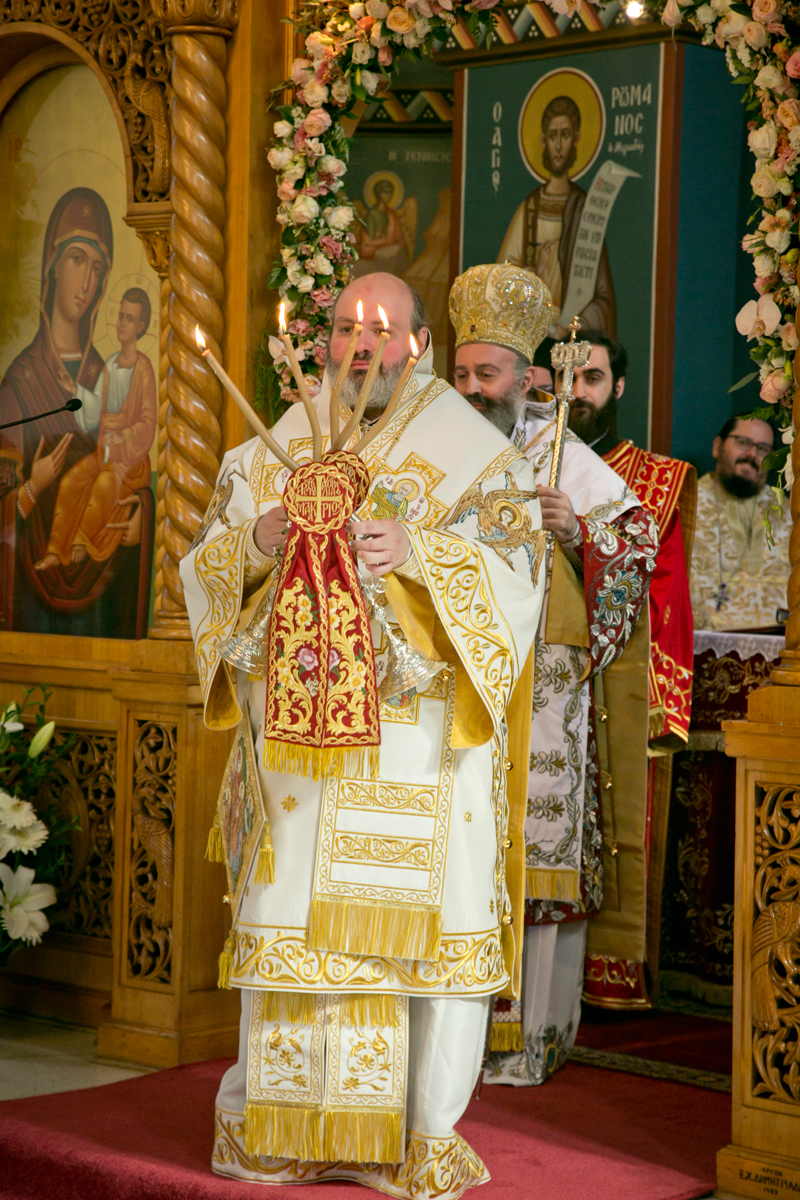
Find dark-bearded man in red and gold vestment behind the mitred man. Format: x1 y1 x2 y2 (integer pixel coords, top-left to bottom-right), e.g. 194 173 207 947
570 330 697 1008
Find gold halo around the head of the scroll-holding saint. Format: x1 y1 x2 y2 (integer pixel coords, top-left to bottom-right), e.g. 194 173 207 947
519 68 606 184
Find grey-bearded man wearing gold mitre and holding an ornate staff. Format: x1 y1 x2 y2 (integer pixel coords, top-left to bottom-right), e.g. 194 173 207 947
450 264 657 1085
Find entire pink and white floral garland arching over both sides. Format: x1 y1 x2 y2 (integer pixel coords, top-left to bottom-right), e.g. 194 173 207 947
267 0 800 482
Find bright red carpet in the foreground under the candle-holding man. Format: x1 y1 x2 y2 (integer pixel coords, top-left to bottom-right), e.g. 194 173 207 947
0 1061 730 1200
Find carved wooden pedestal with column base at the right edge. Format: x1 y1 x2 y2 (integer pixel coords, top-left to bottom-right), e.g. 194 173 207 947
715 331 800 1200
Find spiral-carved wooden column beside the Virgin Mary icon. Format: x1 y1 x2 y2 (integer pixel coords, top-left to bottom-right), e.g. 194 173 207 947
150 0 239 640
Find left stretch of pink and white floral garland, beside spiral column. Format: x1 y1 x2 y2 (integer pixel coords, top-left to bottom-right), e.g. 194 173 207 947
258 0 501 420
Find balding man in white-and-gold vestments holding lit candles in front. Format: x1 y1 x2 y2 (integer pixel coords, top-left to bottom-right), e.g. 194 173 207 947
181 274 547 1200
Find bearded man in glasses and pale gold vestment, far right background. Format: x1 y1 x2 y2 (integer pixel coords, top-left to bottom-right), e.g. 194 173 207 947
690 416 792 629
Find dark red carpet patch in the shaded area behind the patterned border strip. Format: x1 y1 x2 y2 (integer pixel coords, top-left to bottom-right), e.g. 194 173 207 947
576 1004 733 1075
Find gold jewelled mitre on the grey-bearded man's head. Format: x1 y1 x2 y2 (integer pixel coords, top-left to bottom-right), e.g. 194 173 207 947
450 263 552 362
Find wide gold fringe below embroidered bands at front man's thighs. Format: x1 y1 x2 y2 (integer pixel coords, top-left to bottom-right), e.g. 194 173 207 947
307 895 441 962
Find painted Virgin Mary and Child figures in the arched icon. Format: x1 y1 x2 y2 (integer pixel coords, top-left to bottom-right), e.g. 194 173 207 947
0 187 157 637
